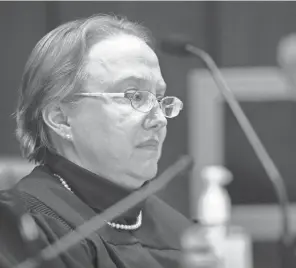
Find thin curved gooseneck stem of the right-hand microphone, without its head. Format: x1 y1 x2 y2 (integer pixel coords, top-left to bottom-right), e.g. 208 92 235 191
185 44 293 267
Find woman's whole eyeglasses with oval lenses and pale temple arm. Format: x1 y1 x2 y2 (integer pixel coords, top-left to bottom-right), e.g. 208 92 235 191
75 90 183 118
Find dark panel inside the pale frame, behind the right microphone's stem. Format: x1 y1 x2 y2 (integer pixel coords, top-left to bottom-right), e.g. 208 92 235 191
224 101 296 204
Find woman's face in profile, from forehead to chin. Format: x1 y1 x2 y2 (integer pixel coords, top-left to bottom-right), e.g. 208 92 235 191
69 34 167 188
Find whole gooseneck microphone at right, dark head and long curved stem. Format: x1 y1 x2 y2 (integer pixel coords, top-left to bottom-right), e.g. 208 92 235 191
160 36 292 249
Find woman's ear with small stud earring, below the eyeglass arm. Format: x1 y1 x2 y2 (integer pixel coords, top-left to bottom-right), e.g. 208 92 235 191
42 104 72 140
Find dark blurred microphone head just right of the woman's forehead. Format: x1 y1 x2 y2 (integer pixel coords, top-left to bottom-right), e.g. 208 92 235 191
159 36 190 57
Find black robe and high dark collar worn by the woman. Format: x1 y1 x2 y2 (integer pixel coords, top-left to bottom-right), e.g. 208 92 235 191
11 155 190 268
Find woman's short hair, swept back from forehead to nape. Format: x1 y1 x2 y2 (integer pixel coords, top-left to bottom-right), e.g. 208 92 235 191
15 15 154 163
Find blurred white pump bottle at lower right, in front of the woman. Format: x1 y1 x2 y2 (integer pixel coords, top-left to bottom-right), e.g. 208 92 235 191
198 165 253 268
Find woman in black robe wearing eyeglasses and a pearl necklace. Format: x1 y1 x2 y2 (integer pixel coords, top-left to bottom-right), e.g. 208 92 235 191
12 16 190 268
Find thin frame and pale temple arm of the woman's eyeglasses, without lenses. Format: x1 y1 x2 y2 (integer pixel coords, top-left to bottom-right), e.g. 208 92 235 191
74 90 183 118
